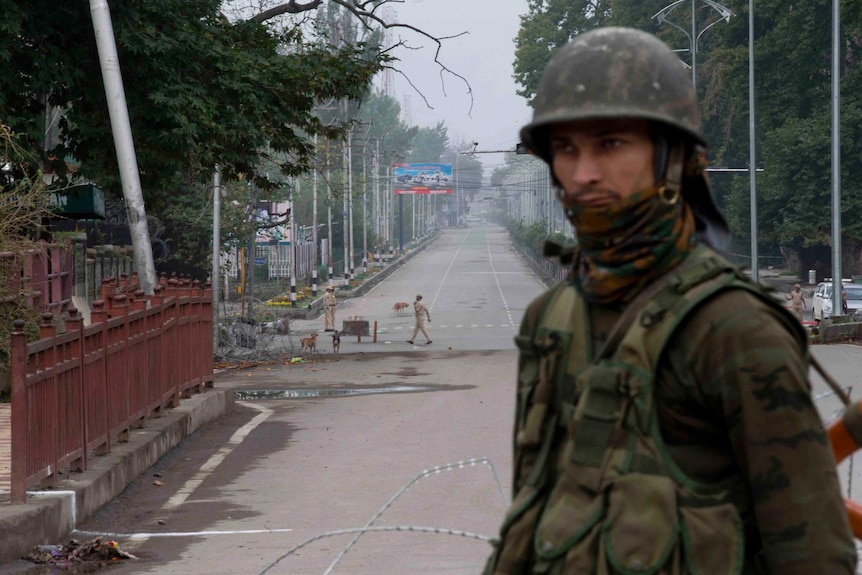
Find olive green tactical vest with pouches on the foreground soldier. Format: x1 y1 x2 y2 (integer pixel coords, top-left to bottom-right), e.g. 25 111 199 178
484 246 807 575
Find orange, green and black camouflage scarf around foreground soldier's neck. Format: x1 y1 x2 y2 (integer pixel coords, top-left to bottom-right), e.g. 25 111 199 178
567 188 695 304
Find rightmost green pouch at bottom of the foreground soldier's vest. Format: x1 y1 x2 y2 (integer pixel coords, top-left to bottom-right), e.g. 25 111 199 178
680 503 745 575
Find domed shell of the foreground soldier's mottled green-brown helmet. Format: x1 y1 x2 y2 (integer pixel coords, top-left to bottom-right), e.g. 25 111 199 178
521 28 705 160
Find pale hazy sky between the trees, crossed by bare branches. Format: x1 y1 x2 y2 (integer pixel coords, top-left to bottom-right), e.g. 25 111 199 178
380 0 532 175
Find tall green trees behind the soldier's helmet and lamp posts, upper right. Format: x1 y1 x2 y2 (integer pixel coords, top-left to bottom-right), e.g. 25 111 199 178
512 0 862 275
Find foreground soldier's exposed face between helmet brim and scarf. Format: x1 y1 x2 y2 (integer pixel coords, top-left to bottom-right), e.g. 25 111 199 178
550 119 655 208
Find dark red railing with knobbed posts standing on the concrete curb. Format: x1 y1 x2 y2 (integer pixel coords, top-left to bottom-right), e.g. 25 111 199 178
11 279 213 503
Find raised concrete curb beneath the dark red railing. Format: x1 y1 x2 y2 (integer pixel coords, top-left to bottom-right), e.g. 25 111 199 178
0 388 234 565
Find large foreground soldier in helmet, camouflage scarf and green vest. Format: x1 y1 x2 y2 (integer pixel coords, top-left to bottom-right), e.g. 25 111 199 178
485 28 856 575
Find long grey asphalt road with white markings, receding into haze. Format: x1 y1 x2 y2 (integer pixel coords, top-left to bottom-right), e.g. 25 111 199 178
0 226 862 575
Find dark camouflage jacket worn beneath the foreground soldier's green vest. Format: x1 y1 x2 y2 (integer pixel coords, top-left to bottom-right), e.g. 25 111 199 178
492 252 856 575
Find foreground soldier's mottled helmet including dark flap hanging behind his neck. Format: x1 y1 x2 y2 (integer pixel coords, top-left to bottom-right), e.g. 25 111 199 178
521 27 729 251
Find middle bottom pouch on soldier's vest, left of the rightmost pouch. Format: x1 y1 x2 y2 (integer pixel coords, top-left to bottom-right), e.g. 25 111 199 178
603 473 680 575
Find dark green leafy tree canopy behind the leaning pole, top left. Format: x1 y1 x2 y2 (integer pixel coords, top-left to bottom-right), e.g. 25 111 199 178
0 0 389 270
